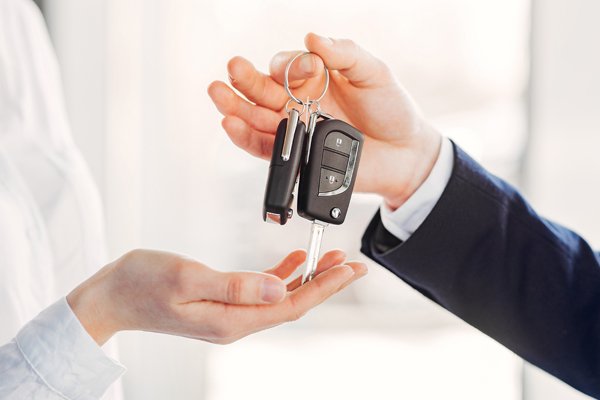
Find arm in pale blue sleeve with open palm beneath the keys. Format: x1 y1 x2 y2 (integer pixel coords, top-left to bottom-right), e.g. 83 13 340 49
0 250 366 400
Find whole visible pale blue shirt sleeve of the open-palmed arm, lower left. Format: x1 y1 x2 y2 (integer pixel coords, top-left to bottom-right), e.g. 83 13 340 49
0 297 125 400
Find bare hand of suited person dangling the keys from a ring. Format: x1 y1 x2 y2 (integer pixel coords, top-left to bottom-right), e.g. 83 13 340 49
209 34 441 209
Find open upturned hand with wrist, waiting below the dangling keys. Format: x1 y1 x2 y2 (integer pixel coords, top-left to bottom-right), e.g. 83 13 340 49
67 250 367 344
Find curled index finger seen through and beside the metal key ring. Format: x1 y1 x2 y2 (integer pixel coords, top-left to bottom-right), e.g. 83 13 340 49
269 51 323 88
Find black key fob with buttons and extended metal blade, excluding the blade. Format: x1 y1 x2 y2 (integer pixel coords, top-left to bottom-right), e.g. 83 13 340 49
298 119 364 225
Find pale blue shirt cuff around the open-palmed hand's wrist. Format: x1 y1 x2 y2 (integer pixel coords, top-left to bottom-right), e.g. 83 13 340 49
15 297 125 399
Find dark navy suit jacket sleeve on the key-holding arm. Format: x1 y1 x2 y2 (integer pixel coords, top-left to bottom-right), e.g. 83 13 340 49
362 146 600 397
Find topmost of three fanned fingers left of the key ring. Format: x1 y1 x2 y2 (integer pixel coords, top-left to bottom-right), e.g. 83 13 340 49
227 57 288 110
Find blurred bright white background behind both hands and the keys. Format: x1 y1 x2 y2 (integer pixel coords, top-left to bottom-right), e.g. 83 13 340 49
39 0 600 400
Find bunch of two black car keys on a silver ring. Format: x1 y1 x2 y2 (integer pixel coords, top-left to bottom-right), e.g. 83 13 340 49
263 53 363 283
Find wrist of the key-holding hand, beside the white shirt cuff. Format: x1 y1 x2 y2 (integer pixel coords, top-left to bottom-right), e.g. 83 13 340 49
379 123 442 211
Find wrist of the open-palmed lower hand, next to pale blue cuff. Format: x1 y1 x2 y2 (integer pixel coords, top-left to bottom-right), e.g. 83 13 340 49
67 266 120 346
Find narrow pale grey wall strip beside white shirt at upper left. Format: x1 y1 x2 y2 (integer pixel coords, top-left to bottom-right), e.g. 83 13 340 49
44 0 107 193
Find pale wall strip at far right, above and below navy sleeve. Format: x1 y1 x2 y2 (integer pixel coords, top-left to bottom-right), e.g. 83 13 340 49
524 0 600 400
